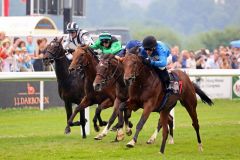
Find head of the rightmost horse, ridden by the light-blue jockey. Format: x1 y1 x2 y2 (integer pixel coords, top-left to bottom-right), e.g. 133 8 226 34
123 50 143 85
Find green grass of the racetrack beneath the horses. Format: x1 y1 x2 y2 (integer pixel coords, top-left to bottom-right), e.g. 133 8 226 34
0 100 240 160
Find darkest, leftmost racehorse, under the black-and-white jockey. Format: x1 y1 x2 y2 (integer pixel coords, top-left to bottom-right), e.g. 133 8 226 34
43 38 104 138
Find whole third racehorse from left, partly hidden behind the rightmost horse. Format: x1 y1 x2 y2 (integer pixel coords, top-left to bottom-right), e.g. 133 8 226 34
93 54 173 144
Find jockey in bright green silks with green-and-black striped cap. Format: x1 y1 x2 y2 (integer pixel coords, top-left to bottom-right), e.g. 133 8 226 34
90 32 122 55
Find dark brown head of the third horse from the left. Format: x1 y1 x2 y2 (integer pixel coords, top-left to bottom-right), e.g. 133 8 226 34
93 54 120 91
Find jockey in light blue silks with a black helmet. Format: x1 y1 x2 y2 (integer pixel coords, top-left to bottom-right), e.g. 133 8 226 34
141 36 172 111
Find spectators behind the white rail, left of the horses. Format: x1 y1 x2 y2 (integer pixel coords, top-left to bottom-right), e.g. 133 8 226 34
0 32 52 72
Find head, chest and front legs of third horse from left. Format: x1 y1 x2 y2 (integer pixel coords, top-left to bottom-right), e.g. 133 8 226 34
93 54 132 140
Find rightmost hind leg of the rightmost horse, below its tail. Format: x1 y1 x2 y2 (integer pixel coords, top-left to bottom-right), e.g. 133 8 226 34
180 99 203 152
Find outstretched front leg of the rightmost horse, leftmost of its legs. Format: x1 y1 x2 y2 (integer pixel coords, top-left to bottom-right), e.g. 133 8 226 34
127 102 153 148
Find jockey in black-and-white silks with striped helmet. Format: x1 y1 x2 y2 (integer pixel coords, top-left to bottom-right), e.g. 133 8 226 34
63 22 94 60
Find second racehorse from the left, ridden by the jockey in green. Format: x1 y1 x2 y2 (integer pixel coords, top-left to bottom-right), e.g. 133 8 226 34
66 45 131 140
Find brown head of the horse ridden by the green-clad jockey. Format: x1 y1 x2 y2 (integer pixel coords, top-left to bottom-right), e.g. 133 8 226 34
68 45 92 72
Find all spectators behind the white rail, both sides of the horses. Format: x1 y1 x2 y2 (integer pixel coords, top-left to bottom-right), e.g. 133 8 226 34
0 32 240 72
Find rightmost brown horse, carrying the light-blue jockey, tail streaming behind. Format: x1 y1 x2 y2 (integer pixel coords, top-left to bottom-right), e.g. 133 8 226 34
123 52 213 154
